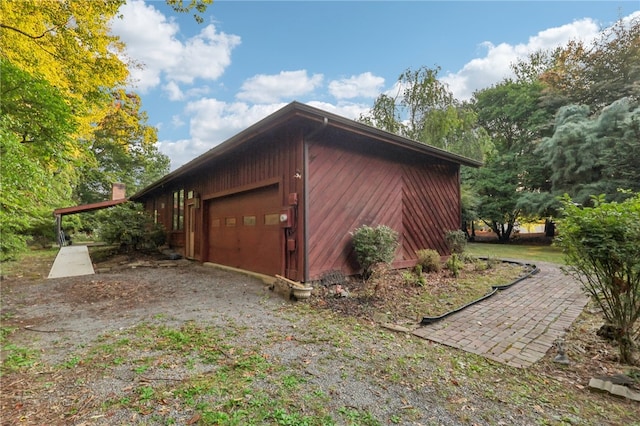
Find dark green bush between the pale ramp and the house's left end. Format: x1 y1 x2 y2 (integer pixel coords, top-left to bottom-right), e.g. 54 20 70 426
98 202 166 251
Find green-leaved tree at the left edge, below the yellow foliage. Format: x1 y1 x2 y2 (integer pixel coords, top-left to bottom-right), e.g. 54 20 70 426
0 60 79 260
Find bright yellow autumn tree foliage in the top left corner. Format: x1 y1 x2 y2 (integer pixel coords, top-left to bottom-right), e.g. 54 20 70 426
0 0 128 137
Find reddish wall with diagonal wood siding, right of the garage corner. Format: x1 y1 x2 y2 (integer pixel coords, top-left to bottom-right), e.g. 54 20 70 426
308 135 460 280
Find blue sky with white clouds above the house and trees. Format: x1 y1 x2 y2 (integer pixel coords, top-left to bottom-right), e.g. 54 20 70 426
112 0 640 169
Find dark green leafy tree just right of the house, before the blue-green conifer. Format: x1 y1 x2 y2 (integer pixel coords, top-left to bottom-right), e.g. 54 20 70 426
471 78 553 241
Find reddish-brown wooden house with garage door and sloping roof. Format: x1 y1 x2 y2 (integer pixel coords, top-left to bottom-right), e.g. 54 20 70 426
131 102 480 282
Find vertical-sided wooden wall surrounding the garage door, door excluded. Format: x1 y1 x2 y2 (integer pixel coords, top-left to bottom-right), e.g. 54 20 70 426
140 126 304 280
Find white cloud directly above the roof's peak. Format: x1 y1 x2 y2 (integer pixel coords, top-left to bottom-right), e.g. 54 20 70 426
236 70 324 104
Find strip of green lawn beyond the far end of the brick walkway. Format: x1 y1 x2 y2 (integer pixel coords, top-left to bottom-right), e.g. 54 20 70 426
466 243 564 265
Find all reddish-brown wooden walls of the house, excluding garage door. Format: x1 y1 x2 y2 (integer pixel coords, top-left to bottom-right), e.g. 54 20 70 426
138 112 460 281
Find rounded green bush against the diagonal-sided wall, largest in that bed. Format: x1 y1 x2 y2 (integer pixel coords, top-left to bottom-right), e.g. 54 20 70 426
351 225 398 278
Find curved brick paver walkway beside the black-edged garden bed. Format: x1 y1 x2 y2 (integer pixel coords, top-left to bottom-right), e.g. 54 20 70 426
413 263 588 367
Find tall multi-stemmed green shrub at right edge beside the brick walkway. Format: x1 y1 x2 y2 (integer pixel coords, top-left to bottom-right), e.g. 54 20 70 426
556 194 640 363
